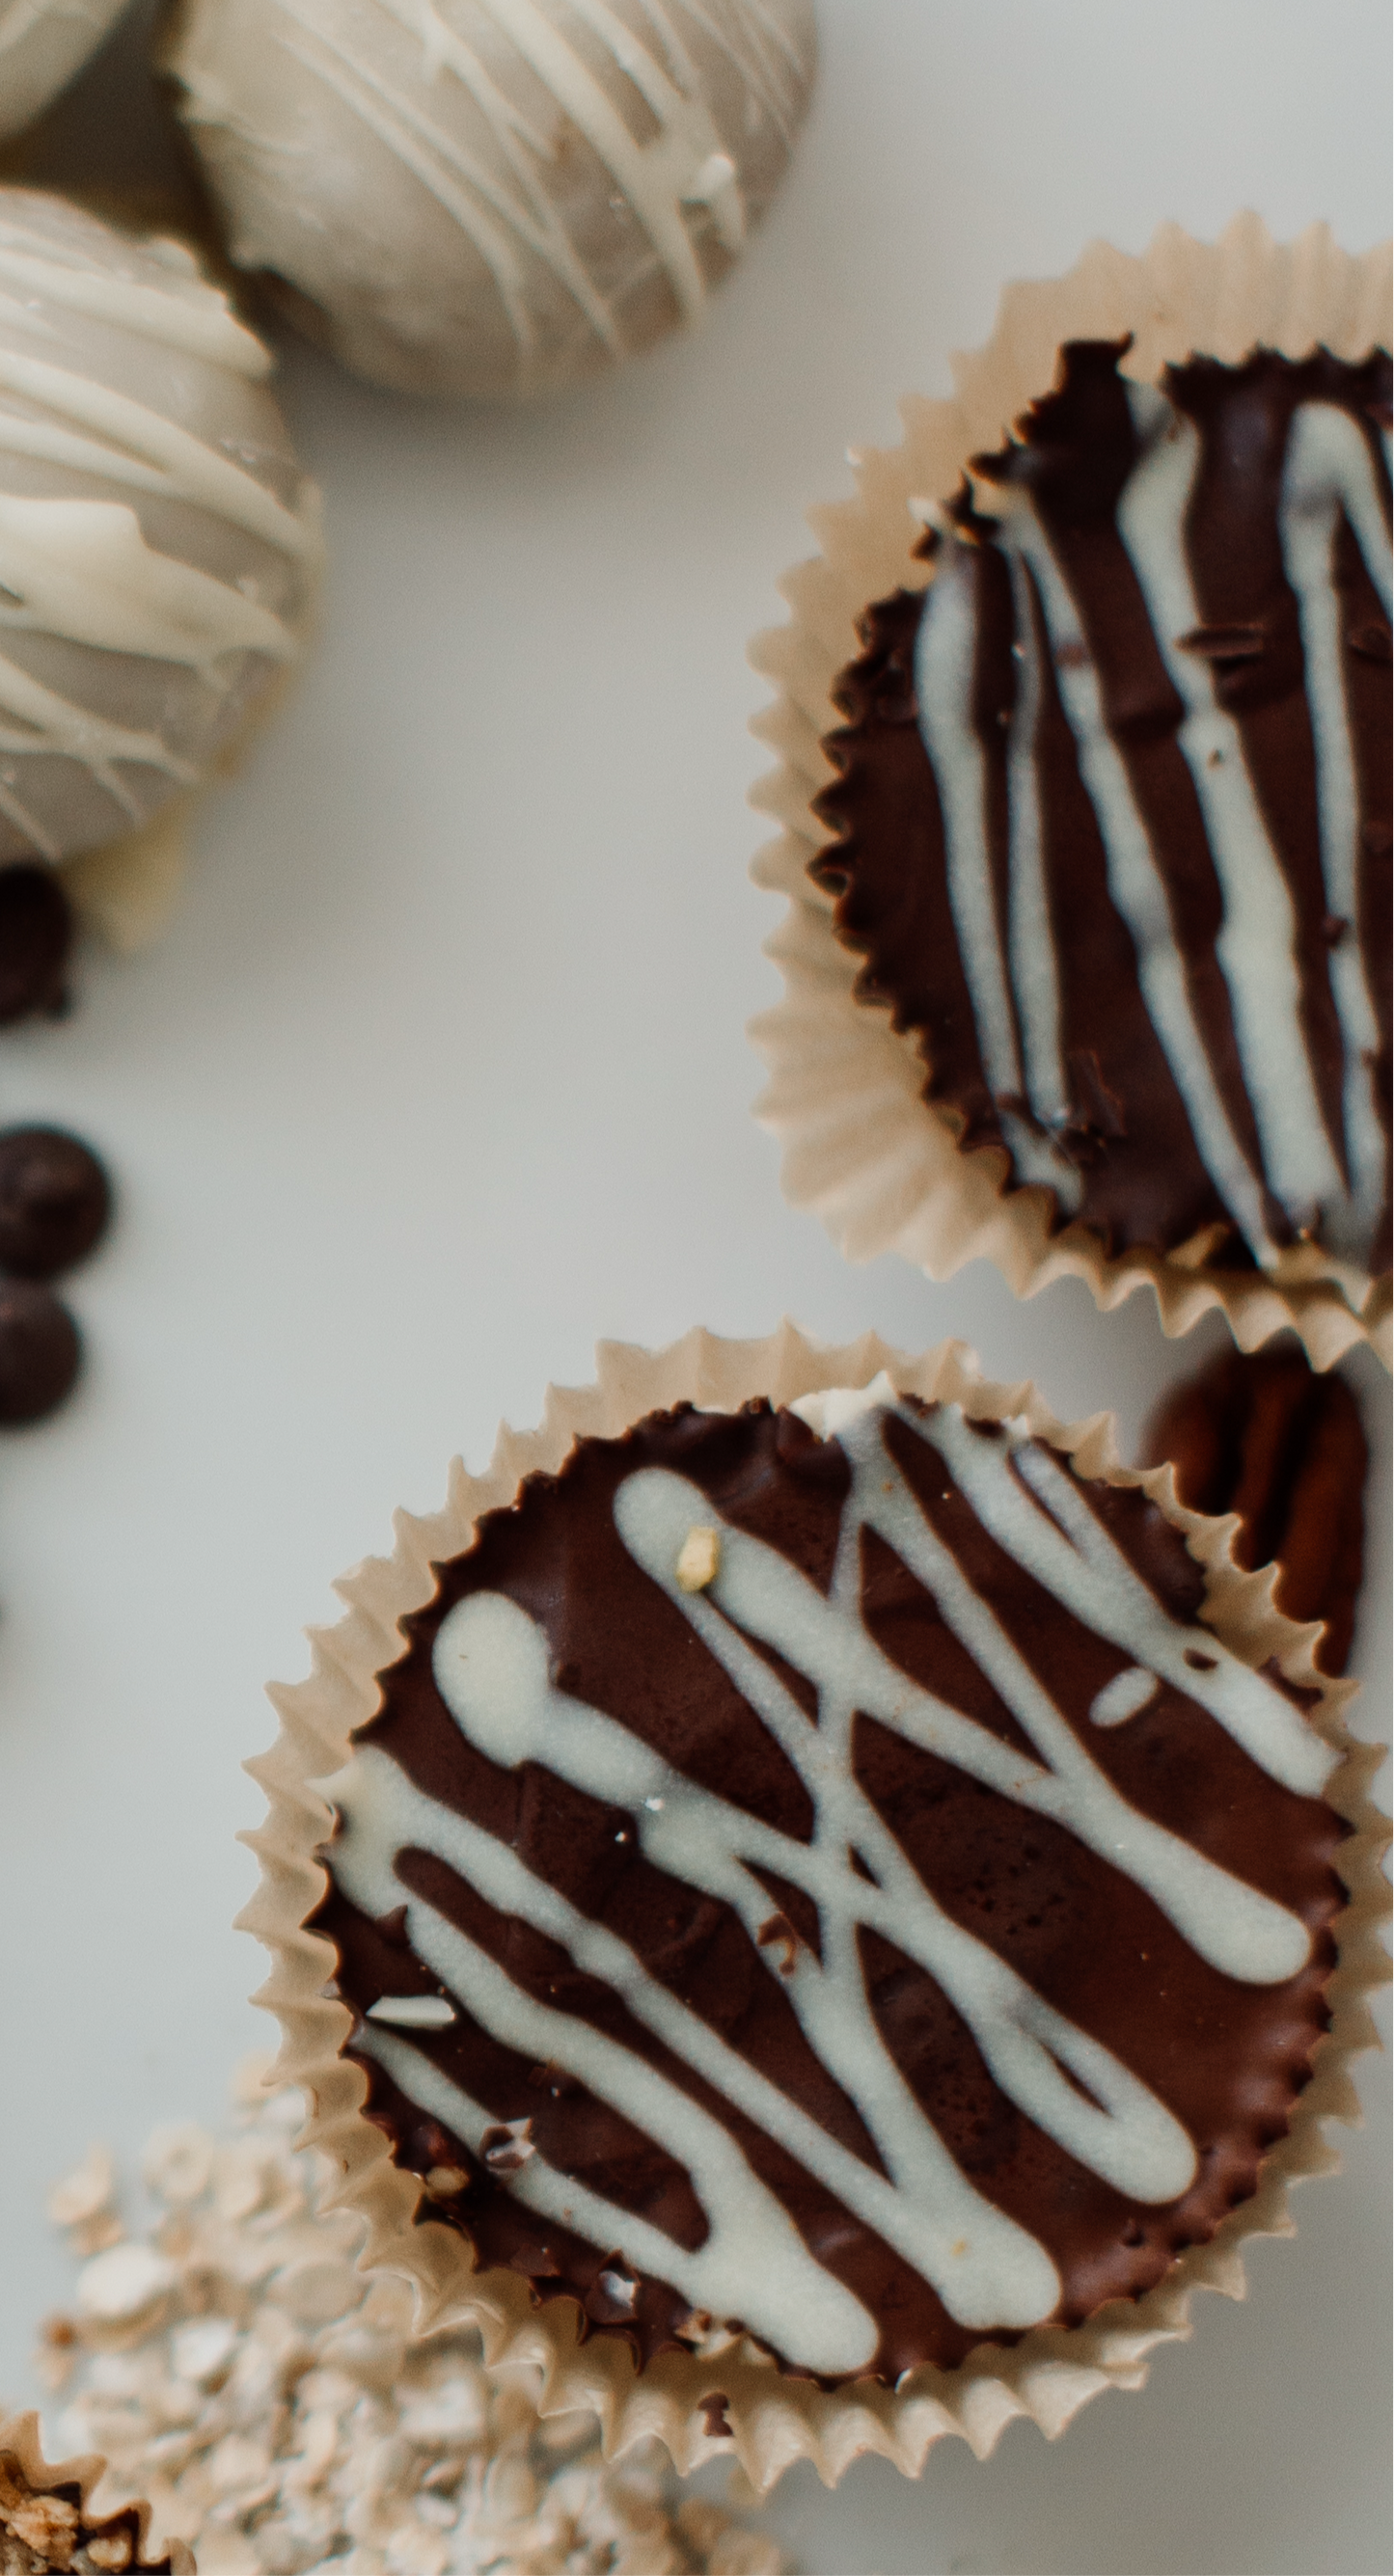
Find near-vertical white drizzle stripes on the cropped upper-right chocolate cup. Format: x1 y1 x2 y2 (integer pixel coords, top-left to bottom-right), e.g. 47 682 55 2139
915 384 1394 1267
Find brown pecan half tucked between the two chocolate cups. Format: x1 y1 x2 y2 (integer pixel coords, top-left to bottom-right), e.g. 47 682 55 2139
1141 1350 1368 1671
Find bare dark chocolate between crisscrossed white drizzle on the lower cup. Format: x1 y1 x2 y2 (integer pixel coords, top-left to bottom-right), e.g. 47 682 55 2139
312 1404 1345 2383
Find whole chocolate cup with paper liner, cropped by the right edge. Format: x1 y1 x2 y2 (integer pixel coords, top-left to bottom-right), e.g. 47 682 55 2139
752 216 1394 1368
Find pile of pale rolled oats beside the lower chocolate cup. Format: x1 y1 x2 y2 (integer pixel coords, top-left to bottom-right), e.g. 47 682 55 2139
39 2069 786 2576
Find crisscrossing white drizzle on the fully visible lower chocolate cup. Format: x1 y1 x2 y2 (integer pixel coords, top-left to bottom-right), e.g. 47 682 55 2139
322 1381 1332 2370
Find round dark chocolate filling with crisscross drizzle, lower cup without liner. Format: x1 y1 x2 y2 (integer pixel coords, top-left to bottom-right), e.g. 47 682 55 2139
312 1391 1343 2380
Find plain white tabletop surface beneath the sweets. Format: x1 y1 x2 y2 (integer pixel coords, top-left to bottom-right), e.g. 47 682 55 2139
0 0 1394 2576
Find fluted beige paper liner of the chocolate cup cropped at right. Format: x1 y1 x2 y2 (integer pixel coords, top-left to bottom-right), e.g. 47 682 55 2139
750 214 1394 1368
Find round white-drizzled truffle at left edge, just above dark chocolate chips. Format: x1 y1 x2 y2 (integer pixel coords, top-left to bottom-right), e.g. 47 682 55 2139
0 188 319 860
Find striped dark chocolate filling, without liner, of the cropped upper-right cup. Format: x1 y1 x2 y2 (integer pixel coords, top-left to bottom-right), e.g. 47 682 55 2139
814 340 1394 1272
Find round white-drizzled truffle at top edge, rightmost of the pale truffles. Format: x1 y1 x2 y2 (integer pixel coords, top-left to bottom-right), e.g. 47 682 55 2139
165 0 817 396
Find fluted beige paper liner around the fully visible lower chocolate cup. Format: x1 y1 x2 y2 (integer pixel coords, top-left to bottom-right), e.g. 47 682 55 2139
239 1324 1394 2488
